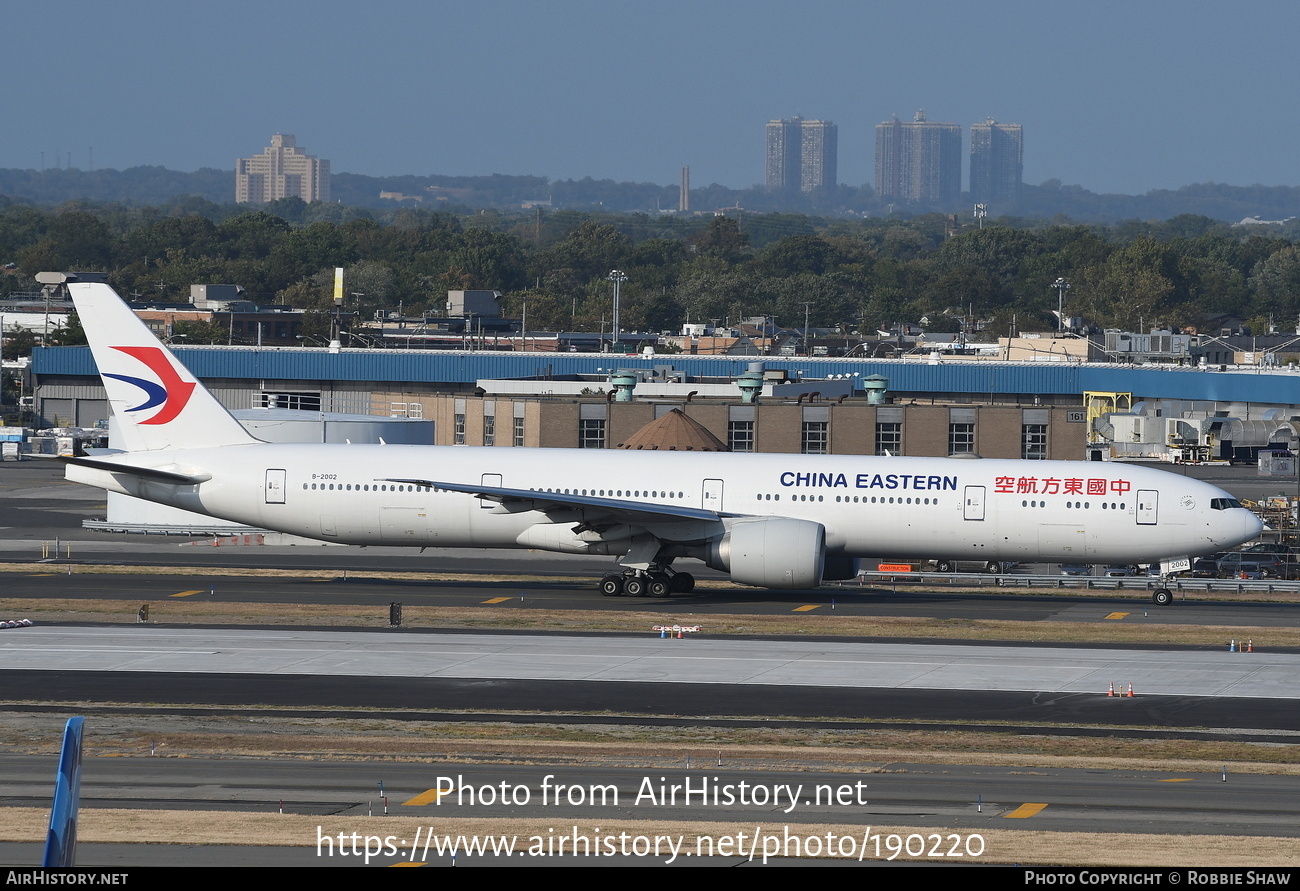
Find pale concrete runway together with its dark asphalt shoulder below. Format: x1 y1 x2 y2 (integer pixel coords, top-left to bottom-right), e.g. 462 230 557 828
0 626 1300 741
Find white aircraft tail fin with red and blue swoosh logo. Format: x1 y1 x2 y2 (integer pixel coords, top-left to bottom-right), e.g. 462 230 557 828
68 282 259 451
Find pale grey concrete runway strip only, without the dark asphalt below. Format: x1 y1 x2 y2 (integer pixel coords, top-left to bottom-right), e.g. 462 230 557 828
0 626 1300 700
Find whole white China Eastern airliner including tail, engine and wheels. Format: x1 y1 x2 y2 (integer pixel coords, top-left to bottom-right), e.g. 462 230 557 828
66 281 1261 604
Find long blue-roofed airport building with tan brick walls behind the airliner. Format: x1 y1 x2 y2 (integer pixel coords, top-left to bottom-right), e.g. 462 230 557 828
31 346 1300 459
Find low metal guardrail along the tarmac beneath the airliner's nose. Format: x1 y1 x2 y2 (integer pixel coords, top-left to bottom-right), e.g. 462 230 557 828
840 570 1300 596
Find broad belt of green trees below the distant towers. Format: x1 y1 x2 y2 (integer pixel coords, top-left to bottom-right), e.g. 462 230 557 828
0 199 1300 337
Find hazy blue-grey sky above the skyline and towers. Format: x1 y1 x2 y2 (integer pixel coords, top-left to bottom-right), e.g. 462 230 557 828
10 0 1300 194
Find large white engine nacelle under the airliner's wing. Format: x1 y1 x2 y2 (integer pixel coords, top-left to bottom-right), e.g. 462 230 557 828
706 516 826 588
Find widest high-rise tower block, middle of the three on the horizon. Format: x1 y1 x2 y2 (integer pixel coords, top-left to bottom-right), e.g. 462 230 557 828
876 112 962 207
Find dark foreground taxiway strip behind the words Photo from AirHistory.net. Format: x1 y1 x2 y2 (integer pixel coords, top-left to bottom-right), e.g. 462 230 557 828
0 752 1300 838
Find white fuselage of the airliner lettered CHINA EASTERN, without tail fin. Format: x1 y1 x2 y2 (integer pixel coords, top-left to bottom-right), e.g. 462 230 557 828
69 444 1258 563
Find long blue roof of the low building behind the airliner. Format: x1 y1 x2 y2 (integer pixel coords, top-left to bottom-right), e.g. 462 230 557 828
33 346 1300 405
